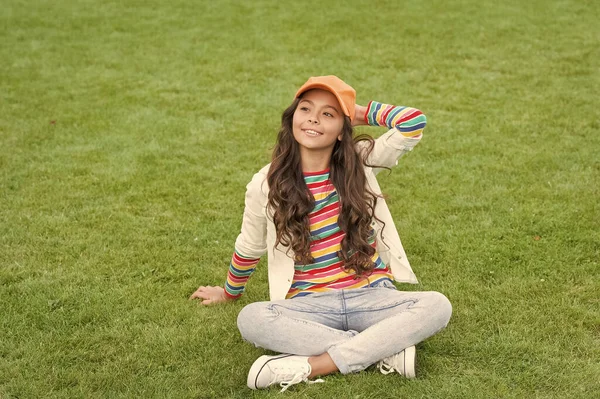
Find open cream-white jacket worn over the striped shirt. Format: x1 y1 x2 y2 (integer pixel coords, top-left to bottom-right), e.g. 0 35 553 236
235 128 421 301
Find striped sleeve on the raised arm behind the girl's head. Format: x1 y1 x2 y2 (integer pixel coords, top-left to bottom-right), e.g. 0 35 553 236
365 101 427 138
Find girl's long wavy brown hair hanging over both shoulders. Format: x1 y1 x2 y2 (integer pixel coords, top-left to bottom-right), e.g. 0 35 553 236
267 98 379 276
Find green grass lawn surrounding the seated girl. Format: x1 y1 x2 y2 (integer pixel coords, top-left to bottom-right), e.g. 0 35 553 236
0 0 600 399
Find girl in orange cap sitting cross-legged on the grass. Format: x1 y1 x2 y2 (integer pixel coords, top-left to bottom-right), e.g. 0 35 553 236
191 76 452 391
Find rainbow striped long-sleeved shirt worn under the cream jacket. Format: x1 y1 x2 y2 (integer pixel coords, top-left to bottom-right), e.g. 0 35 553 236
225 101 426 298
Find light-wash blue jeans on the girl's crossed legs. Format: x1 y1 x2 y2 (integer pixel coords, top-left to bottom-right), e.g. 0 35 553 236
238 282 452 374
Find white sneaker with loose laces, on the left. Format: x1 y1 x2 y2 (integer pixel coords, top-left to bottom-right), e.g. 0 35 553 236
248 355 323 392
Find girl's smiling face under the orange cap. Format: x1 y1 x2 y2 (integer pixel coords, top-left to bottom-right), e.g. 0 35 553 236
292 89 344 158
